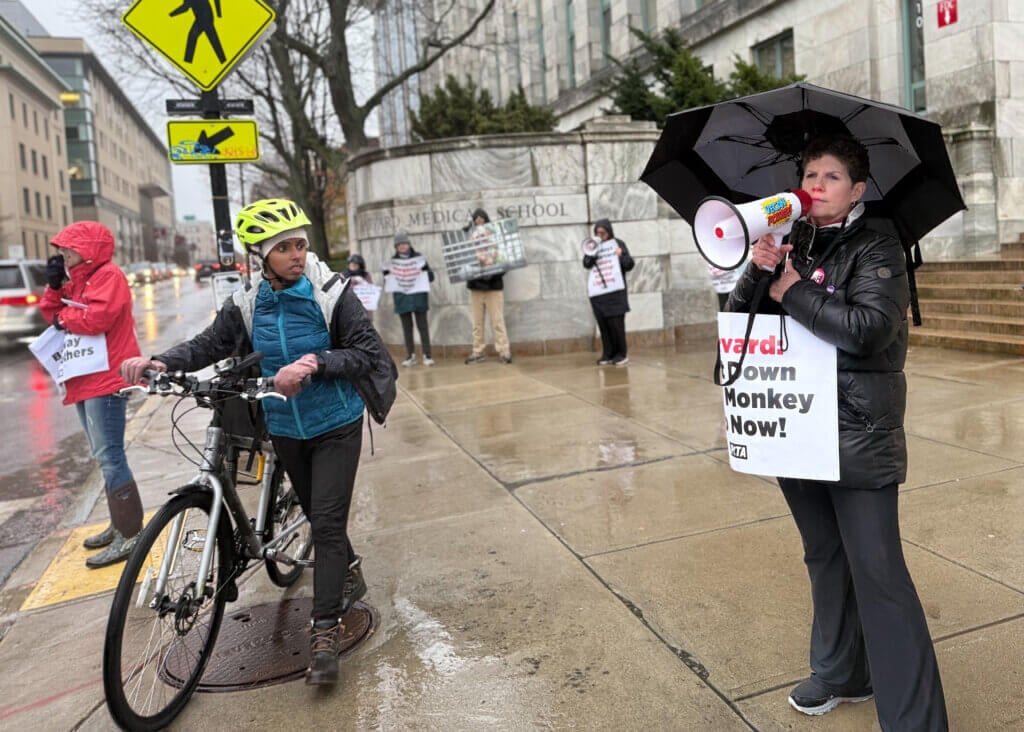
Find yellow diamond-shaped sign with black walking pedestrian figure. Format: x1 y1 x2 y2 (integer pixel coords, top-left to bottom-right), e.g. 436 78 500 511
121 0 275 91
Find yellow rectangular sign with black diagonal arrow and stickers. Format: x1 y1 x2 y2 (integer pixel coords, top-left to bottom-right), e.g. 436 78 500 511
167 120 259 164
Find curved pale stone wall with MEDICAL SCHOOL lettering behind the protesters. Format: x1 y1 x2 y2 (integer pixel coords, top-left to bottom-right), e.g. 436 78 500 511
349 117 717 354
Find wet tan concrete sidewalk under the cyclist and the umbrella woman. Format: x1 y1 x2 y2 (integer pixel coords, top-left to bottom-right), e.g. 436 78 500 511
0 348 1024 730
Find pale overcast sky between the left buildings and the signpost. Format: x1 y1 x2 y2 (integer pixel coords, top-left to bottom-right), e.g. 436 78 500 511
22 0 220 221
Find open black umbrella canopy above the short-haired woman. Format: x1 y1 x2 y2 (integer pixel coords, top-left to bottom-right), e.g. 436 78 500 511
640 82 967 243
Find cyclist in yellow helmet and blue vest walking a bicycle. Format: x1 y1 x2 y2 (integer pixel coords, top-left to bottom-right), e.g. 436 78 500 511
121 199 397 685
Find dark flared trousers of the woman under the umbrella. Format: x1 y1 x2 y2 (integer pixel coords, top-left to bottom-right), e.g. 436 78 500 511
778 478 949 732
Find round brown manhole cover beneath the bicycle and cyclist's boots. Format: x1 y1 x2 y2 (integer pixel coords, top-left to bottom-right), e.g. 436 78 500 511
161 597 377 692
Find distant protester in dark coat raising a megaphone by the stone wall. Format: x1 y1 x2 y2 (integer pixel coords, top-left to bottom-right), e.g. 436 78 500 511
583 219 634 365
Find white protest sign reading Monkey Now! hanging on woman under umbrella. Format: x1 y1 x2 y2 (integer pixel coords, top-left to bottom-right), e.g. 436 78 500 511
718 312 839 480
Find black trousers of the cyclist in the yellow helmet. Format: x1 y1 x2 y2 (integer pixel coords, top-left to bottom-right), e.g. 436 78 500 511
271 417 362 620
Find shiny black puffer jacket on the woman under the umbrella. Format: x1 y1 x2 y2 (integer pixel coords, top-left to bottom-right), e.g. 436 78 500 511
726 218 910 488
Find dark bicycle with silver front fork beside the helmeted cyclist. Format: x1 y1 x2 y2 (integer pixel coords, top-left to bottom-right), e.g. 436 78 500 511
103 352 312 730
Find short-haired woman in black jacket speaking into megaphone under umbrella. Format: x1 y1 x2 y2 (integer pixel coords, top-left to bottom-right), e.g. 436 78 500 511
726 135 948 732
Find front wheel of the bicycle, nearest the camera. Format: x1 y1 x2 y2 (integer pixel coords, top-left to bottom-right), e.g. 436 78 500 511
103 490 233 730
